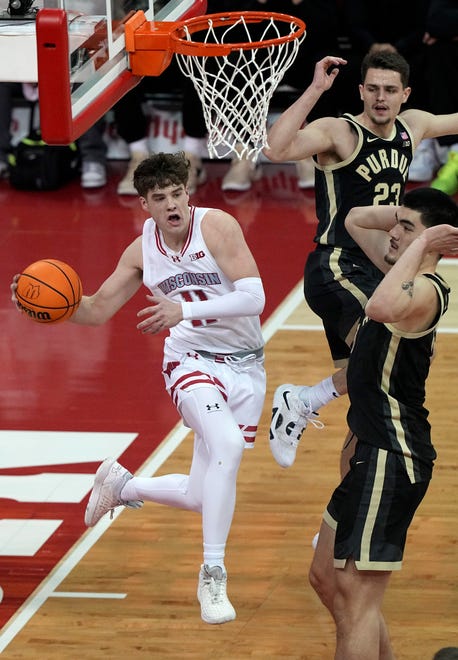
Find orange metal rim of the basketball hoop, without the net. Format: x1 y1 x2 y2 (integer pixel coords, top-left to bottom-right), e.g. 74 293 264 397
170 11 305 57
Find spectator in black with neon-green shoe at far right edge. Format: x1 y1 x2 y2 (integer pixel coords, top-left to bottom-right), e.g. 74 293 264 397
424 0 458 195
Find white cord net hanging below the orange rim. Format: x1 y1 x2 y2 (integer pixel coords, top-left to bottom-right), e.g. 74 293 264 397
176 16 305 162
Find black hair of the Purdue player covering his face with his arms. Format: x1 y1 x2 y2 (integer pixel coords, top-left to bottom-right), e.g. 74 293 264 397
402 188 458 227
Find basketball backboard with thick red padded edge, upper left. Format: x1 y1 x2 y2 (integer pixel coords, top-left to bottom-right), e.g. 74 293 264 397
36 0 207 144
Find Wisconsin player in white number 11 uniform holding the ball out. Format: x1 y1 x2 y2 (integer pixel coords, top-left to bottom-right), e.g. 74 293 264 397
12 153 266 623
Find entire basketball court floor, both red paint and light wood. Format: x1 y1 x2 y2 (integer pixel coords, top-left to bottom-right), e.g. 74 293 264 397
0 162 458 660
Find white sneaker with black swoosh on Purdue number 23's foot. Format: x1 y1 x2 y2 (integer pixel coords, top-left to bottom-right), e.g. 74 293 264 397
269 384 324 467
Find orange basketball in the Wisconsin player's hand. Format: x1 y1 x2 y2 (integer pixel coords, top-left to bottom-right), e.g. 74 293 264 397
16 259 83 323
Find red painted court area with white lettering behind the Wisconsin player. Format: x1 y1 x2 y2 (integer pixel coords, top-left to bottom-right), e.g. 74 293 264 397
0 162 315 627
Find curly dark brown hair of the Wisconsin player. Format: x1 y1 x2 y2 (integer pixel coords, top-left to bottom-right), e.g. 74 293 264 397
134 151 190 197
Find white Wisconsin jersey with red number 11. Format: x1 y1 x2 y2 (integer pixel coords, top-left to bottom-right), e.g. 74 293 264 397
142 206 264 354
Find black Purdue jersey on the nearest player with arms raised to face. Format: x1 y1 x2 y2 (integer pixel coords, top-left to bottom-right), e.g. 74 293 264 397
347 273 450 483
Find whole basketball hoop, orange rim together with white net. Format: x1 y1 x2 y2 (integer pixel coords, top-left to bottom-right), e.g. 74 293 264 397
170 11 305 162
